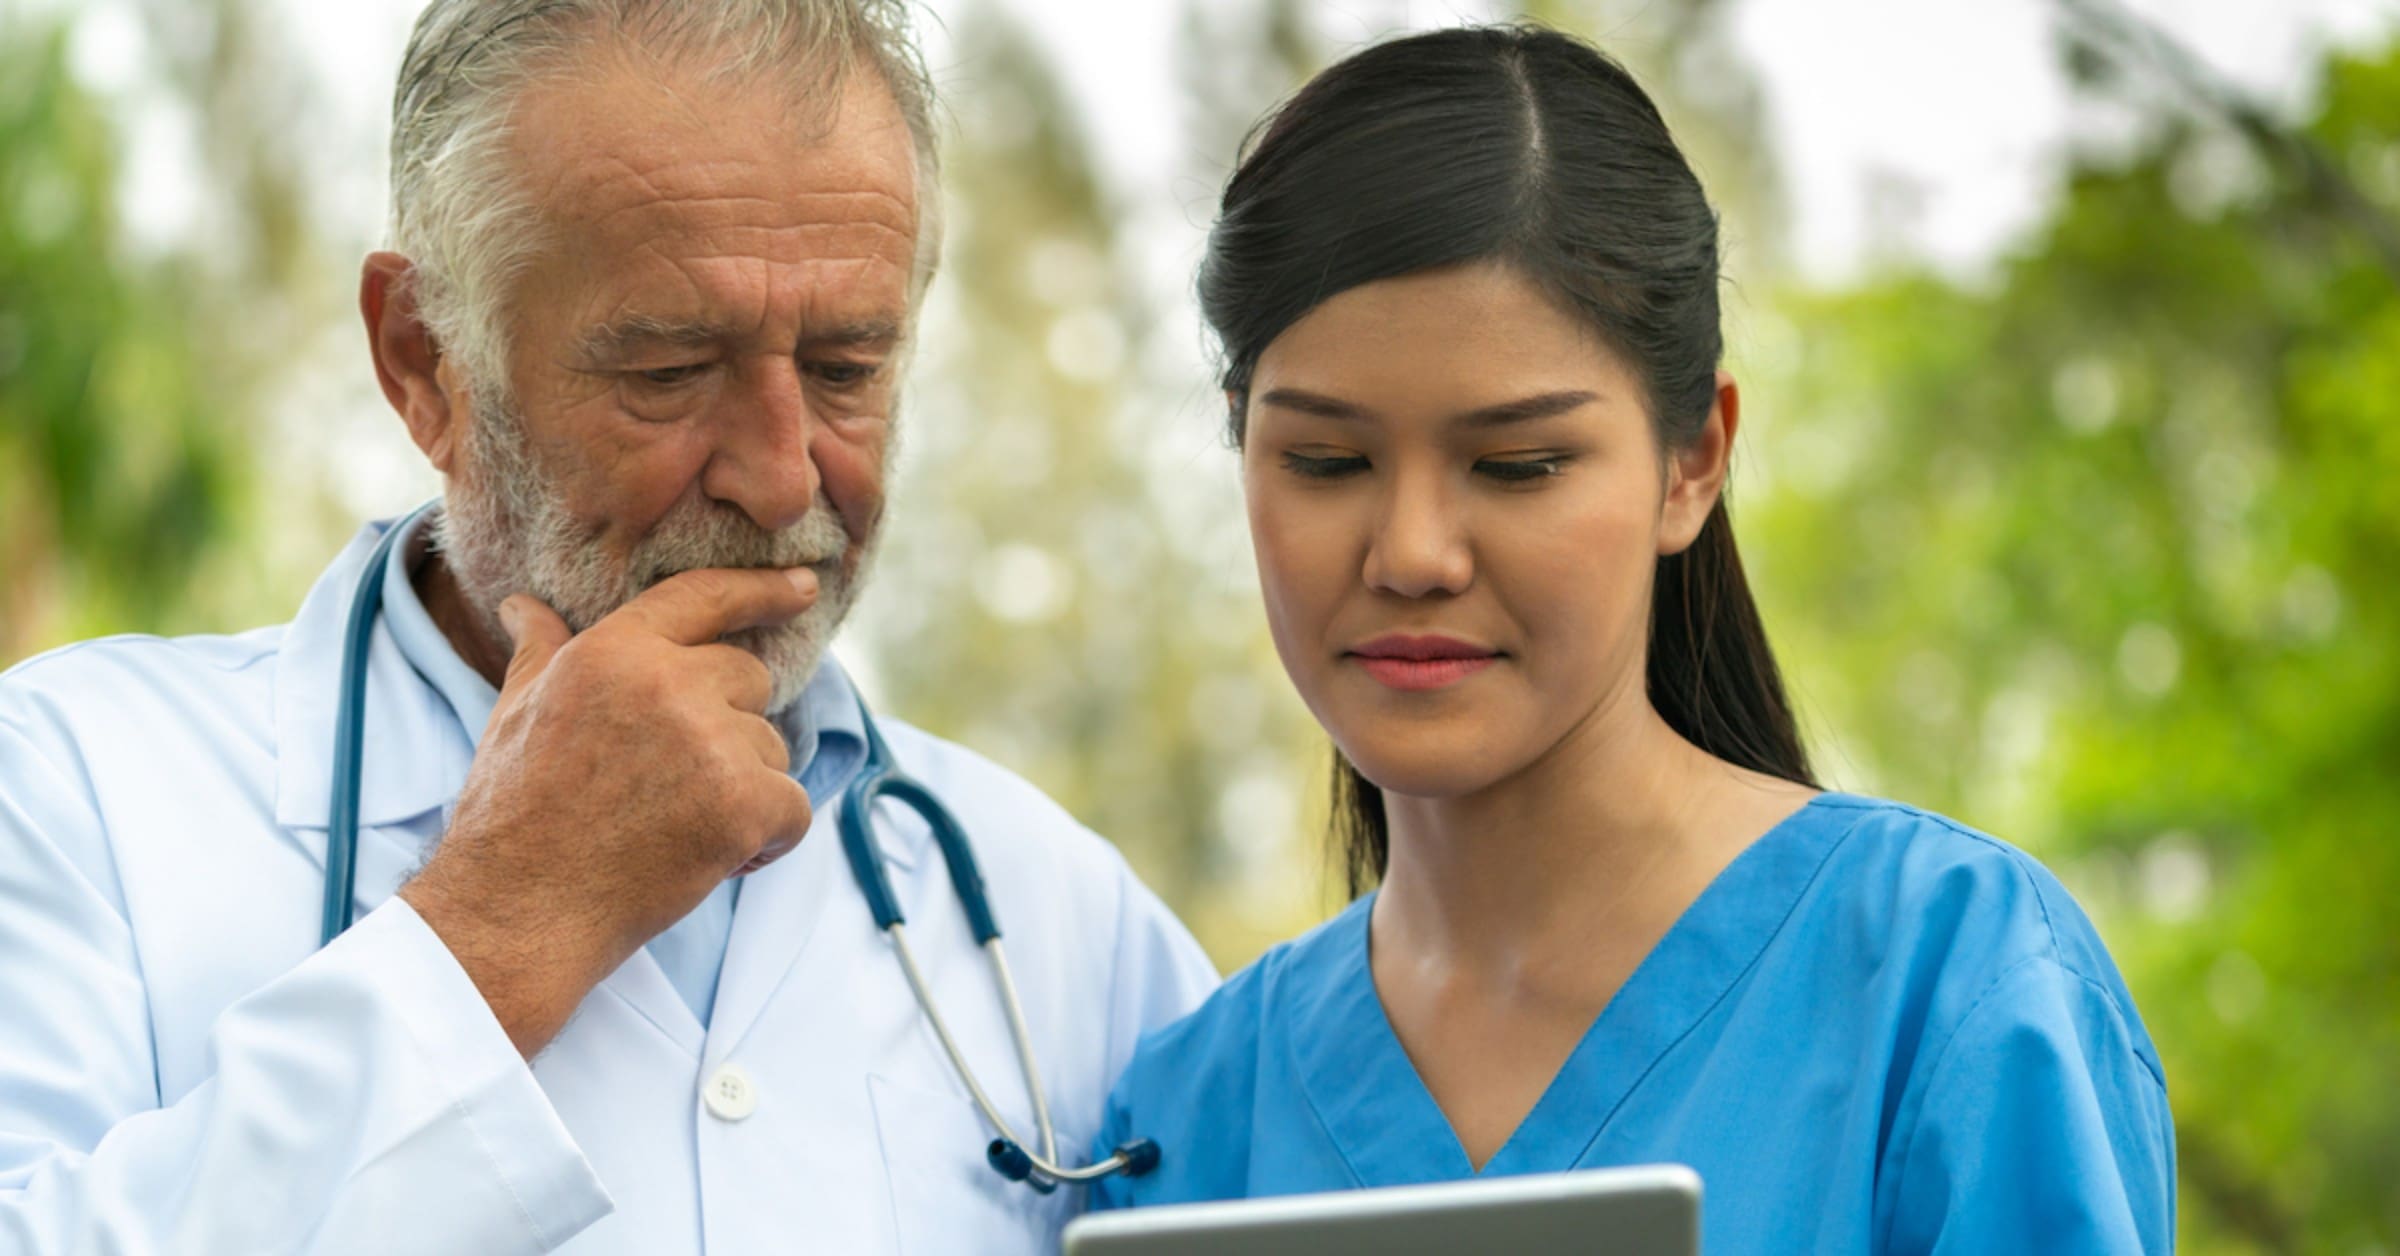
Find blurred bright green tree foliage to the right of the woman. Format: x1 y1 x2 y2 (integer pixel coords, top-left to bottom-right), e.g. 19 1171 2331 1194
1742 34 2400 1254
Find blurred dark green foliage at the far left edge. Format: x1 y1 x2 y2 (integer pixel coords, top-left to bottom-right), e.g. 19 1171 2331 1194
0 17 250 658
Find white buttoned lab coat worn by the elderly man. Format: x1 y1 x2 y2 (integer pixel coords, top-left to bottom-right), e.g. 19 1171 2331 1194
0 516 1217 1256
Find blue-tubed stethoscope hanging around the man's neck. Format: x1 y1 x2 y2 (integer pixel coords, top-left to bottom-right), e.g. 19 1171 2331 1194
319 502 1159 1194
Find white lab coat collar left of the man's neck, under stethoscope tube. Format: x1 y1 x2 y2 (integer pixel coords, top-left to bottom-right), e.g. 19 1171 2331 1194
276 519 451 831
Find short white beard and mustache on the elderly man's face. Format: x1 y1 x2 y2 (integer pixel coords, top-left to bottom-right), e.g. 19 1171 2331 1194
434 389 878 716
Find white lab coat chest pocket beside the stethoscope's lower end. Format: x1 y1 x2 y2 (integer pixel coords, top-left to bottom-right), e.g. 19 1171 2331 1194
866 1076 1092 1256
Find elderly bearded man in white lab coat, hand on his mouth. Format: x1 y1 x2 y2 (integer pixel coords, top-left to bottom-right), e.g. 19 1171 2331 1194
0 0 1214 1254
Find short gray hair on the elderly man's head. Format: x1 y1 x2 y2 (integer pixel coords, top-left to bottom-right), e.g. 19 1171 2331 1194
391 0 941 394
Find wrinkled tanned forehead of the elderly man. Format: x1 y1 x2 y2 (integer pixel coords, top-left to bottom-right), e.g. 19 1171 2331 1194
492 58 919 345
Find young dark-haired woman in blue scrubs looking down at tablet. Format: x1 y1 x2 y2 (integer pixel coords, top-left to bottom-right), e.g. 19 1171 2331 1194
1092 26 2174 1254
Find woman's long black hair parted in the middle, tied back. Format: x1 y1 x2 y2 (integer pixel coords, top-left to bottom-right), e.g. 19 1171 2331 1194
1200 26 1814 896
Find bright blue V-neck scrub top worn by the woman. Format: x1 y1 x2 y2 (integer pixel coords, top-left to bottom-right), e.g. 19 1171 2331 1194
1090 795 2174 1254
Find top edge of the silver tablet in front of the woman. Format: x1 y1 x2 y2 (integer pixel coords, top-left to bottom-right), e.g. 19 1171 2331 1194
1066 1165 1699 1256
